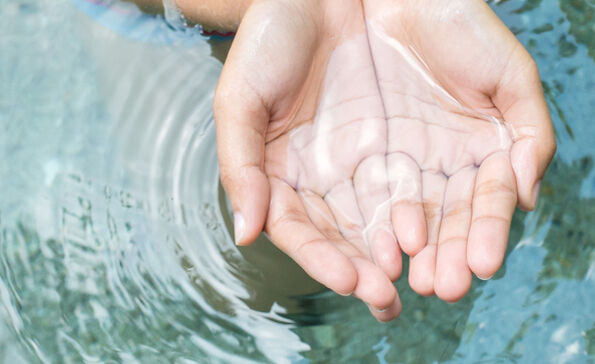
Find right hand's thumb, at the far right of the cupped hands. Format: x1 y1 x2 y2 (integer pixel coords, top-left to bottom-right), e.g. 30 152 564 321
493 54 556 210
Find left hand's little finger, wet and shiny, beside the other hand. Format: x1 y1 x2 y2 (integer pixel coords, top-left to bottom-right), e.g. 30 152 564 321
353 154 402 281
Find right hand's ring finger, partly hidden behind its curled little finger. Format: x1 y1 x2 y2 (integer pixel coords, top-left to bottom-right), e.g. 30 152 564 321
409 171 446 296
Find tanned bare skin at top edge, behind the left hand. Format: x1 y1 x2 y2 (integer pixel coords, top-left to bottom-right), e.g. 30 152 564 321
127 0 253 31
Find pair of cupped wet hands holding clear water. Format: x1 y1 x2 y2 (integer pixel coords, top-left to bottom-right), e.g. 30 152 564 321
214 0 555 321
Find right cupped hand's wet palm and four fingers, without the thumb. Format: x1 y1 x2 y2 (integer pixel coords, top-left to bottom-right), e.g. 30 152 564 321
366 0 544 300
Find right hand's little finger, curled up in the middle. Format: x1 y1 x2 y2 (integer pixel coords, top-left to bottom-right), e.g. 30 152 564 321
387 153 427 255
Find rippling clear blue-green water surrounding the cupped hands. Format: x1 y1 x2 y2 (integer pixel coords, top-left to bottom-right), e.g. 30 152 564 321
0 0 595 363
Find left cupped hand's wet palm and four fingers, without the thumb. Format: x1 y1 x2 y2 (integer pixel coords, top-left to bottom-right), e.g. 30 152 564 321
225 0 401 319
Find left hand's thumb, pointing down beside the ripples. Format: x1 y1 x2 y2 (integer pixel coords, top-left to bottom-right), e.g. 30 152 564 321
213 22 269 245
